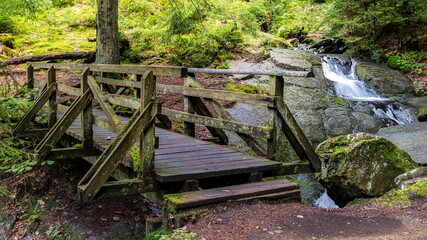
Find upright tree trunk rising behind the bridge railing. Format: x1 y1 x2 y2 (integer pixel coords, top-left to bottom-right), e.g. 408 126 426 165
96 0 120 64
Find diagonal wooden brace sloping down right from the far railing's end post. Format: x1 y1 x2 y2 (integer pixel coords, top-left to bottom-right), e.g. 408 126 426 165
277 101 321 172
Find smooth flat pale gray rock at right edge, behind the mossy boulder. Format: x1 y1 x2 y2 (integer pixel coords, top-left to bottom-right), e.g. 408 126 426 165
376 122 427 165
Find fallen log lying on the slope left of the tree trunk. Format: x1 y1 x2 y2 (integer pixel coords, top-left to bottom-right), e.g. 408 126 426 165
3 51 95 65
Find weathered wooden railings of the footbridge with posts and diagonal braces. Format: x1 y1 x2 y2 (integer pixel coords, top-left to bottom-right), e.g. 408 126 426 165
14 63 320 201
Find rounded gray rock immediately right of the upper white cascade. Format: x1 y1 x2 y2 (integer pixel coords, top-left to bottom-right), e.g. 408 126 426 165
356 61 414 96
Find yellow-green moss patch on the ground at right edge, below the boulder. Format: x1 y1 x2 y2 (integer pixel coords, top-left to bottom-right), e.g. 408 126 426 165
375 180 427 207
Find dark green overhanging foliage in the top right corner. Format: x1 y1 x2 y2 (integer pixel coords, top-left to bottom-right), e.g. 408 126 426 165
328 0 427 52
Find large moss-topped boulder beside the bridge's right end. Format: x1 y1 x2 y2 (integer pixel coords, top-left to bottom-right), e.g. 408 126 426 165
316 133 418 206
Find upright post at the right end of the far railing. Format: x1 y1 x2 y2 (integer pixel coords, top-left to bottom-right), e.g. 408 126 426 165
267 76 284 160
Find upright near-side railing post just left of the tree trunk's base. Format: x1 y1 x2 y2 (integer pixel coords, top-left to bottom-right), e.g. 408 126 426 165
80 68 93 151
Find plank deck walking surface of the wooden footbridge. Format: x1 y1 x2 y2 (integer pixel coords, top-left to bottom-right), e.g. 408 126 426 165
61 109 281 182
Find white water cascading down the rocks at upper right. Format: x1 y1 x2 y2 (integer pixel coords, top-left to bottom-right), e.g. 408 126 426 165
322 56 413 125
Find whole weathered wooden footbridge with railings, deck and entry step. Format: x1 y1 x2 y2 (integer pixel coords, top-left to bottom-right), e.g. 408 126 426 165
14 63 320 221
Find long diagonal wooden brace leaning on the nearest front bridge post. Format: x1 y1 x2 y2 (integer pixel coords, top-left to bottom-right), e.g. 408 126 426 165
78 103 159 202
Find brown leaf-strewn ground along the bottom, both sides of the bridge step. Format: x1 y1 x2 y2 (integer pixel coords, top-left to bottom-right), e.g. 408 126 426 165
0 160 427 240
